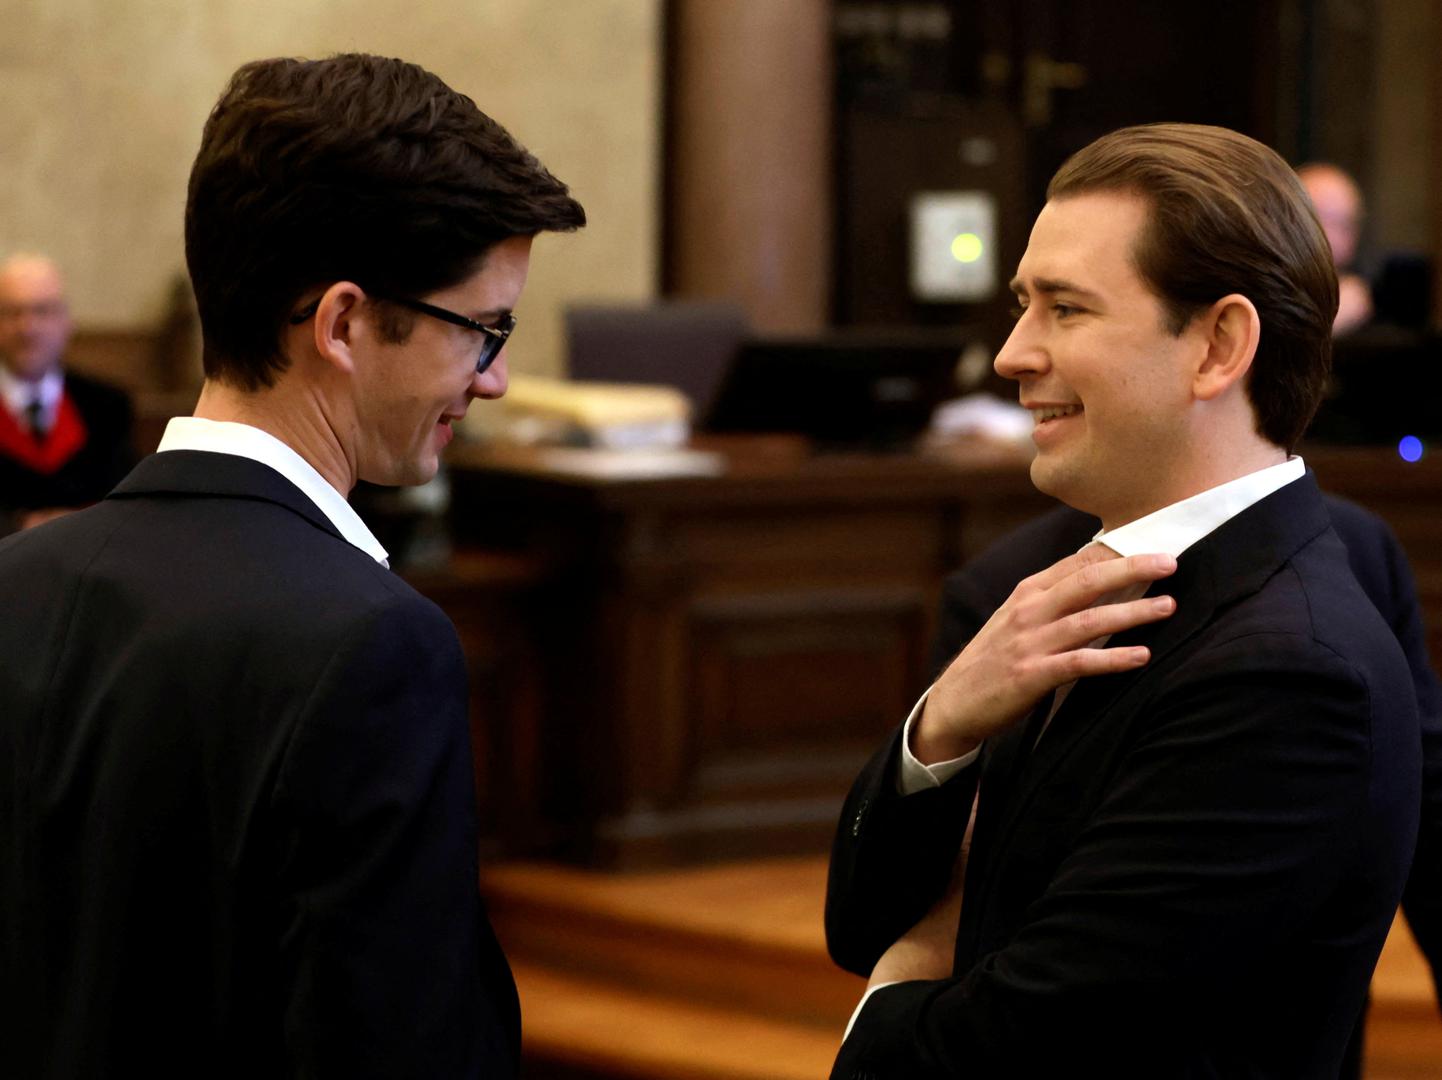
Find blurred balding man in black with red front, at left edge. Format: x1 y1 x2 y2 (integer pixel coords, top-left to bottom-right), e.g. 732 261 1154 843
0 255 136 535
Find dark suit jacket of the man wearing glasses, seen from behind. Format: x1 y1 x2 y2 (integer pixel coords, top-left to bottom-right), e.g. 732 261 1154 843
0 451 519 1079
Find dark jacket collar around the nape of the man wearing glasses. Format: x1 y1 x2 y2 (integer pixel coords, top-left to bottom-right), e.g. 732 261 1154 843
107 450 345 541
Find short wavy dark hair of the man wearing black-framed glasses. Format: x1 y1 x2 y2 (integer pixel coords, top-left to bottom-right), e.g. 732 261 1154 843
185 53 585 391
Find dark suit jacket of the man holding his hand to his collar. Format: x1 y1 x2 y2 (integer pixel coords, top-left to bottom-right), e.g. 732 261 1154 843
826 477 1419 1080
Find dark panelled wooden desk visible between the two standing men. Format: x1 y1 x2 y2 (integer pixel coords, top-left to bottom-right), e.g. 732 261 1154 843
451 440 1050 865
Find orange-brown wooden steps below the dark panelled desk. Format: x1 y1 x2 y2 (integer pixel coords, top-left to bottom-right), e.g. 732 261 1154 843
483 858 1442 1080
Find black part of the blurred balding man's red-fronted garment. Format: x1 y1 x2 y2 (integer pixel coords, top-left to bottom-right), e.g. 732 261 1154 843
0 372 136 512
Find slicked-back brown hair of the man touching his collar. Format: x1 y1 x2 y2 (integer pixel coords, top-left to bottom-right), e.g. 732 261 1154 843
1047 124 1337 450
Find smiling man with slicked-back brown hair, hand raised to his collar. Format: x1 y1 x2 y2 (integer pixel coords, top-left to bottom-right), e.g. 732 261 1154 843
826 124 1420 1080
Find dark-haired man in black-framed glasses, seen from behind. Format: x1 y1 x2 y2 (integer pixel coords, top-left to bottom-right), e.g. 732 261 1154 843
0 55 584 1077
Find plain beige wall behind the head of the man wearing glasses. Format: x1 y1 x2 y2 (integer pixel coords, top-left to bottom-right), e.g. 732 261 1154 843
0 0 660 373
